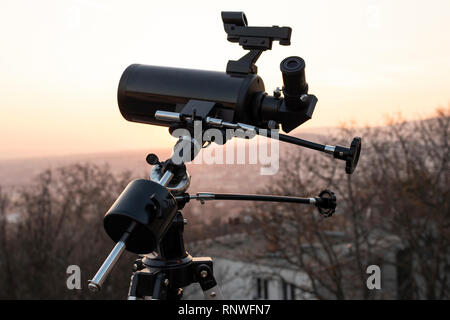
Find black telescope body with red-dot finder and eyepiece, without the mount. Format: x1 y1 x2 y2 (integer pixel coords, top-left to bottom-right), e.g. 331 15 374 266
117 12 317 132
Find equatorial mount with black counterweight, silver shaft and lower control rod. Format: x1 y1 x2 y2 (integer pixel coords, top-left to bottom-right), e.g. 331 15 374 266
89 137 342 299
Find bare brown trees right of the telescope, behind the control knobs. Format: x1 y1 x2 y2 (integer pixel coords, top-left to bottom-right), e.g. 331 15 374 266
249 110 450 299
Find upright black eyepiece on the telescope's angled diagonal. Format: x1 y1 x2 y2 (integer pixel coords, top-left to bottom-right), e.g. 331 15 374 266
280 56 308 109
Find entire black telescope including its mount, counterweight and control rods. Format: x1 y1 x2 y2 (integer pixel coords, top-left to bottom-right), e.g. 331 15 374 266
89 12 361 300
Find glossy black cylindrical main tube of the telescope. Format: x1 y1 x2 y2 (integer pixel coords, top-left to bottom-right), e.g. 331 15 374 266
117 64 264 126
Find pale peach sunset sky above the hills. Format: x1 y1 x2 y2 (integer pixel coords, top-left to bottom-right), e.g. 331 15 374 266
0 0 450 159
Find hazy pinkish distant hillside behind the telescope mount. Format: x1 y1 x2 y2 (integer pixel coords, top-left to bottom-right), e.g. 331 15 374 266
0 134 327 220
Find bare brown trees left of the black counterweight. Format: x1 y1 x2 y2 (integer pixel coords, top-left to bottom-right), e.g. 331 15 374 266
0 164 140 299
